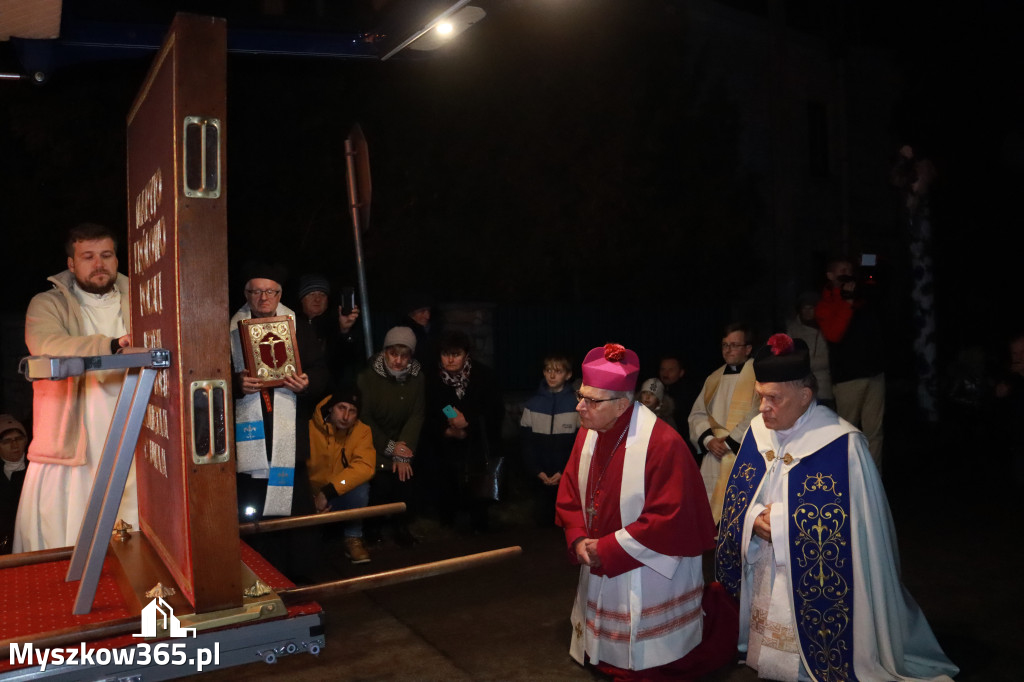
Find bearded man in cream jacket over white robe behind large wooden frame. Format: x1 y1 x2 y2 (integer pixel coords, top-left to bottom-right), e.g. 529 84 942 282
14 223 138 552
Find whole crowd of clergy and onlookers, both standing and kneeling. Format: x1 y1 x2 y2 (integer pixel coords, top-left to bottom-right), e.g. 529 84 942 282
8 224 1024 680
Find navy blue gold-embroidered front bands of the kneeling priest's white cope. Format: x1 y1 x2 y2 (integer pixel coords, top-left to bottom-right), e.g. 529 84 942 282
715 433 857 682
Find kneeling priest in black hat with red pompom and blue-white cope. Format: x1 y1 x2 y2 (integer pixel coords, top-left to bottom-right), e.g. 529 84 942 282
716 334 958 681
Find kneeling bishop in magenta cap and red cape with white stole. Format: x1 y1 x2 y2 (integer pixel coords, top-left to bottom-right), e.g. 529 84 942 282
556 343 735 680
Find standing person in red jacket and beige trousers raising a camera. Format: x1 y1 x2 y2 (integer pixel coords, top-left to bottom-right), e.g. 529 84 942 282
814 258 886 472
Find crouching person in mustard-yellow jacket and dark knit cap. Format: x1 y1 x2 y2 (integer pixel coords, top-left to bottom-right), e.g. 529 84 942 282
306 386 377 563
